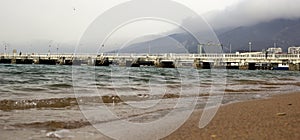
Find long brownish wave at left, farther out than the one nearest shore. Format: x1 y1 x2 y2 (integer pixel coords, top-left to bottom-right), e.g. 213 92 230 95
0 94 180 111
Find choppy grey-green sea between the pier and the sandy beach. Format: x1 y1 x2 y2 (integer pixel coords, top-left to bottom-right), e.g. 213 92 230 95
0 64 300 139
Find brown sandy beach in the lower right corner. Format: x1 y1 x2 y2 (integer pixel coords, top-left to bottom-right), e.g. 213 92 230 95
164 92 300 140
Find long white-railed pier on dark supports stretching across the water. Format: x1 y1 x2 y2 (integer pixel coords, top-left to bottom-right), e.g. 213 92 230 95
0 53 300 71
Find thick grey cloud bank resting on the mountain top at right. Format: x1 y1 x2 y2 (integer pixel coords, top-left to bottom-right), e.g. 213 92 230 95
204 0 300 29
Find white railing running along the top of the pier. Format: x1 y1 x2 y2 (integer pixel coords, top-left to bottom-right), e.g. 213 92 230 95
0 53 300 60
